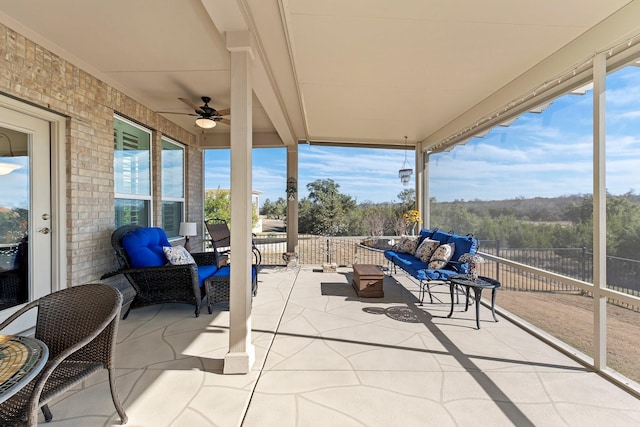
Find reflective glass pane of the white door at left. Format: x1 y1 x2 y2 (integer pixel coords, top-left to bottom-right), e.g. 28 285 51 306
0 127 31 310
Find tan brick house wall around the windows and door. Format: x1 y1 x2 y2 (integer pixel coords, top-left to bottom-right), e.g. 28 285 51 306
0 24 203 287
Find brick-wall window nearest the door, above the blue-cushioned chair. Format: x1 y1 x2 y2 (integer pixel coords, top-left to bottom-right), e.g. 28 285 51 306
113 113 151 228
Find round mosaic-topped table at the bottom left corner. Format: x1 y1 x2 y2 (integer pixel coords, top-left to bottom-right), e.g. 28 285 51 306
0 335 49 403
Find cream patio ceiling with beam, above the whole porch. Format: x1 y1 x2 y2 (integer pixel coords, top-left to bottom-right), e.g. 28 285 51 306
0 0 632 149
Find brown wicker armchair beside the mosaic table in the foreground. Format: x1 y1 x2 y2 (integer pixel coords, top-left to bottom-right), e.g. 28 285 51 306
0 284 127 426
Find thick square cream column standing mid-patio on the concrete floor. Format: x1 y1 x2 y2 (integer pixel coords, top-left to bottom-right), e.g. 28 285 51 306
223 31 255 374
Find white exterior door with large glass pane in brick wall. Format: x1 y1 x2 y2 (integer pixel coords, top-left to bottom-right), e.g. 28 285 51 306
0 106 55 326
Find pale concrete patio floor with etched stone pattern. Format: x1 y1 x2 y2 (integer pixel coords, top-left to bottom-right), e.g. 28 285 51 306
40 266 640 427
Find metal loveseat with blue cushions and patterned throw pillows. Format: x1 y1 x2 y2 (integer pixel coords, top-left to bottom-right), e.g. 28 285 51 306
384 229 478 305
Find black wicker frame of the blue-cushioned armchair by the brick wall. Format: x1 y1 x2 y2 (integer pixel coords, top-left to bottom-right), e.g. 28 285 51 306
102 225 218 319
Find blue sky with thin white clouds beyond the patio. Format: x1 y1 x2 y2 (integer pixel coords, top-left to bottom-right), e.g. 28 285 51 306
205 67 640 207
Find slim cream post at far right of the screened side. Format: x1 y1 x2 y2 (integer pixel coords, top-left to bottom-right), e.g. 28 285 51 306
593 53 607 371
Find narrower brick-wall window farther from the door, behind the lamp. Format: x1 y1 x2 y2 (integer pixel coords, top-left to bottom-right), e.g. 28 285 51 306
162 138 184 238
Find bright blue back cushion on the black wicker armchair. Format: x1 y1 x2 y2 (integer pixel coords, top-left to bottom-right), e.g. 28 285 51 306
122 227 171 268
